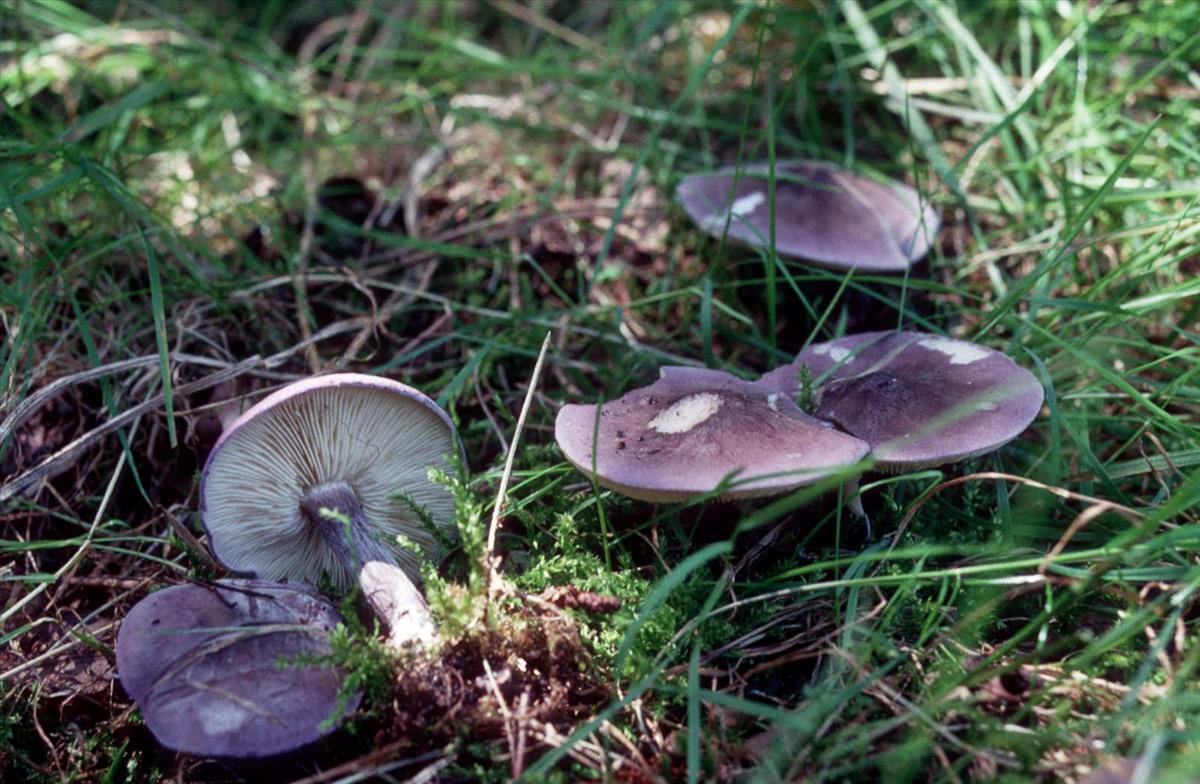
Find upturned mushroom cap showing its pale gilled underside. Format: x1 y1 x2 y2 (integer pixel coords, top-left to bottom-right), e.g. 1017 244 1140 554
200 373 461 588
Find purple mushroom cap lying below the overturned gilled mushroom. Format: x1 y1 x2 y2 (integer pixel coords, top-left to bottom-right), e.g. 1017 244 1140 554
116 580 359 758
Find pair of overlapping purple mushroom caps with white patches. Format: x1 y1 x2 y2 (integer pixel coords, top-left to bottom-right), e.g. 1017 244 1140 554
554 331 1042 501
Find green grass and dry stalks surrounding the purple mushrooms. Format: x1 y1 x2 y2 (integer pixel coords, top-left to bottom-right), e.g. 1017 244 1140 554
0 0 1200 782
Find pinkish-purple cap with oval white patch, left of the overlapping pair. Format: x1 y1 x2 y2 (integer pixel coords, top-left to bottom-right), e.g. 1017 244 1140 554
554 367 868 502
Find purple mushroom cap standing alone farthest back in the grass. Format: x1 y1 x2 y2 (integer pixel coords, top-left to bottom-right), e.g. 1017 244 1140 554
676 161 941 273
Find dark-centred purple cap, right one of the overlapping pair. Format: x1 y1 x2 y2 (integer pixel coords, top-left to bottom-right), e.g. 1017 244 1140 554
760 331 1043 471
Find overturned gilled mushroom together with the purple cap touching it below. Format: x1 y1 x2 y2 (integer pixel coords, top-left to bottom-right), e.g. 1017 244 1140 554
116 373 462 758
